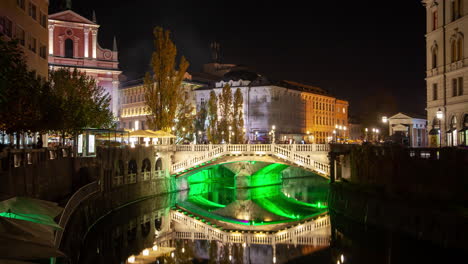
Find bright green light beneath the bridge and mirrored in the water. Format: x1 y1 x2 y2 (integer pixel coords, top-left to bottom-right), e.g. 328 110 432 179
179 162 328 225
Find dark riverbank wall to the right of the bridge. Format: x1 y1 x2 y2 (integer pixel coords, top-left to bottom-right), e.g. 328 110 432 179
329 146 468 249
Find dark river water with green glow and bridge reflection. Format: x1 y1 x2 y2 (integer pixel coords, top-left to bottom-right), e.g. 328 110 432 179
80 164 468 264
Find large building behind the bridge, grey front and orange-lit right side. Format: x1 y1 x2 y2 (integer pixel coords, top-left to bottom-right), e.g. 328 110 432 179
194 67 348 143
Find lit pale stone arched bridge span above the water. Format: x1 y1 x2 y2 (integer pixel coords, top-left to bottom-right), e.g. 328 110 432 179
170 144 330 178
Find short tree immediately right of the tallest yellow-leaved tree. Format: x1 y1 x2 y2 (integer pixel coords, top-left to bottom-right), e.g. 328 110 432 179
175 93 194 142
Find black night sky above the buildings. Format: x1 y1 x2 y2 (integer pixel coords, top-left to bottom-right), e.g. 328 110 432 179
51 0 426 117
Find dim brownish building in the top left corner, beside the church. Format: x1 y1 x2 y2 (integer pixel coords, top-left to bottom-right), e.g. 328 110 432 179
0 0 49 79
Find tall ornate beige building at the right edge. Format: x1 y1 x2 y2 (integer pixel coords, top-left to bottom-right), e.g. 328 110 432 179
422 0 468 146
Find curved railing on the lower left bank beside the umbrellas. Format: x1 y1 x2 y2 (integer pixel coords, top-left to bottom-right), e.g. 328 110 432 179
54 181 99 248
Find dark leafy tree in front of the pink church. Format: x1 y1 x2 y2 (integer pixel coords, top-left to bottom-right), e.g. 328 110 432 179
47 68 114 142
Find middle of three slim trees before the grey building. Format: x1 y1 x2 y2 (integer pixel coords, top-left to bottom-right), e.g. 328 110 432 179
218 84 232 141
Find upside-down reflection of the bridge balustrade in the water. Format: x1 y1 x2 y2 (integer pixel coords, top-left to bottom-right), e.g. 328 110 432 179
165 210 330 246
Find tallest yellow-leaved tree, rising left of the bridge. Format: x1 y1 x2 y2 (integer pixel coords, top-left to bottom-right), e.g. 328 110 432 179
145 27 189 132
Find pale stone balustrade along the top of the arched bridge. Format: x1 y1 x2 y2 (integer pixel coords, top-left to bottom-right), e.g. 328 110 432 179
171 144 330 176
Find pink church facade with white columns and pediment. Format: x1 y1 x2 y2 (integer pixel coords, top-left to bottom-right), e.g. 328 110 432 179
48 10 121 117
